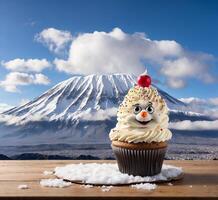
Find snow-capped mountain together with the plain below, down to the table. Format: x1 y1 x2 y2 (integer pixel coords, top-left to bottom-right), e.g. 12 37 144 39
0 74 218 160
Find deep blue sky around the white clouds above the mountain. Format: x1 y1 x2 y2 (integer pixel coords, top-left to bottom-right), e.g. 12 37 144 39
0 0 218 108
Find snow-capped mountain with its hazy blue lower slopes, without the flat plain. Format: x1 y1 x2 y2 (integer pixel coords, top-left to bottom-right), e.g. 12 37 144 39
0 74 210 146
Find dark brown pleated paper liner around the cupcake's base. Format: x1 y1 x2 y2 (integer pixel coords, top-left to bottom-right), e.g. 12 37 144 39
111 145 167 176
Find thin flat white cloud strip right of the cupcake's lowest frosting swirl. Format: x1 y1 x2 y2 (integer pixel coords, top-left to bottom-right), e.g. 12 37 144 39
169 120 218 131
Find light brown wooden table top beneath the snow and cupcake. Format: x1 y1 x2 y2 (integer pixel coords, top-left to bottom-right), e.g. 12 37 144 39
0 160 218 200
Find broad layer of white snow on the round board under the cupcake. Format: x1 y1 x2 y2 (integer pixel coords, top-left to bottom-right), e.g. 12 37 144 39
54 163 183 185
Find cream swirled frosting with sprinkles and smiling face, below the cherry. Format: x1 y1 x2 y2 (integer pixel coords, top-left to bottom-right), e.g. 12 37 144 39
109 85 172 143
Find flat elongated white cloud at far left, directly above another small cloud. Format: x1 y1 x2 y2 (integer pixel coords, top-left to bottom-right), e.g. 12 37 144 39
1 58 51 72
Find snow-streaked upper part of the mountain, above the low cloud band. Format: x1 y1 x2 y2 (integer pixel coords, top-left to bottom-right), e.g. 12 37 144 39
4 74 185 123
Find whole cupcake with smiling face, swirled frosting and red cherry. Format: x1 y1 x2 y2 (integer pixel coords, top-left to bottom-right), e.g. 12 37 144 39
109 74 172 176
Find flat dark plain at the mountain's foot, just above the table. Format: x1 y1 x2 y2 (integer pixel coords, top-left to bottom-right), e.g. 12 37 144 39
0 137 218 160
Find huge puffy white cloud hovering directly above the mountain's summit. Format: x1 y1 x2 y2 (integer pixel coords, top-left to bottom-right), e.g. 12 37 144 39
51 28 215 88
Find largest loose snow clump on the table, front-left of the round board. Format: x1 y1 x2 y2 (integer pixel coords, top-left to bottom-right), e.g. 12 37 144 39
40 179 71 188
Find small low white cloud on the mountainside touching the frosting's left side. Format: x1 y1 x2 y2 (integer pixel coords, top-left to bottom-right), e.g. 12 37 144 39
78 108 117 121
